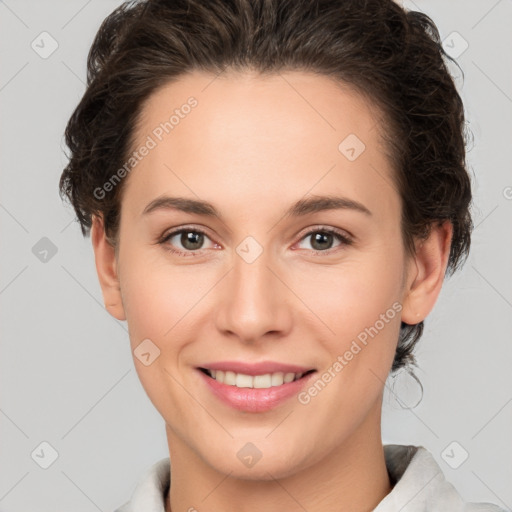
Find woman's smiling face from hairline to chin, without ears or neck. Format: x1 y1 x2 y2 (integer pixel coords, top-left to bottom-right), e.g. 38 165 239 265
95 72 419 479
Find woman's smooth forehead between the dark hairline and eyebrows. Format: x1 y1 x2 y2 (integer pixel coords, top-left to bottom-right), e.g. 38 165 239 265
123 71 397 223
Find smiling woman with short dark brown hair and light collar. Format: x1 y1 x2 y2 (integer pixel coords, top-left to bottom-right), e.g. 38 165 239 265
60 0 500 512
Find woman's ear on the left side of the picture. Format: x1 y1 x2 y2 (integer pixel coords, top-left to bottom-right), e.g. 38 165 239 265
91 216 126 320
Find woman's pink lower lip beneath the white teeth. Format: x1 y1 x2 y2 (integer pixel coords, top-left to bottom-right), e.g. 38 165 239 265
197 370 316 412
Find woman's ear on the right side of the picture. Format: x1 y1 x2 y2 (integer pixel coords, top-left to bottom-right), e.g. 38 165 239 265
402 221 453 325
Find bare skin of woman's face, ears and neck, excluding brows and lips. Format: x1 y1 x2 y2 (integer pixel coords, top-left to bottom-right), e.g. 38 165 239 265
91 71 452 512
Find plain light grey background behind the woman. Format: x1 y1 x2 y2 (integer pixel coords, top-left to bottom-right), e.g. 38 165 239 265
0 0 512 512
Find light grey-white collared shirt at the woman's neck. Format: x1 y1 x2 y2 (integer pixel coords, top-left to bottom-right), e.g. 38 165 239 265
115 444 505 512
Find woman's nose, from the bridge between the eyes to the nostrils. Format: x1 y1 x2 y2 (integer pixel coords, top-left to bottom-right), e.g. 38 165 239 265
217 241 289 341
